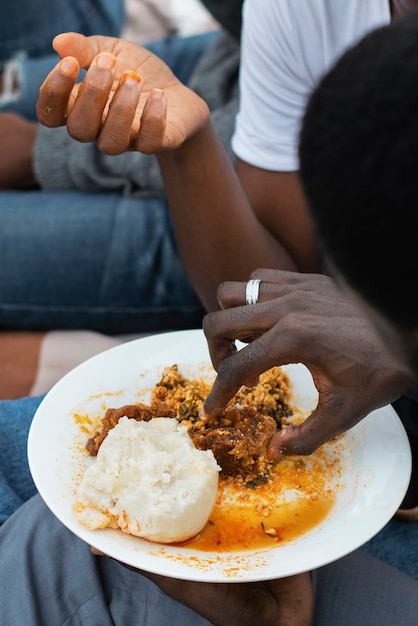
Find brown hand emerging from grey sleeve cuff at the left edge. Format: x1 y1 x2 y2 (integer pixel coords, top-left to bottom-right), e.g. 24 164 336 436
0 113 38 189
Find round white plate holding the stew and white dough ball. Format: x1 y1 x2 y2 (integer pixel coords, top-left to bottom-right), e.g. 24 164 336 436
28 330 411 582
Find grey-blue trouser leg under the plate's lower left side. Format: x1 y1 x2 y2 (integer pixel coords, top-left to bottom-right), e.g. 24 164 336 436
0 496 209 626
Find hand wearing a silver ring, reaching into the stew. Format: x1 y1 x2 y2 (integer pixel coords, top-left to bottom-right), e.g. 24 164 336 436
203 269 414 460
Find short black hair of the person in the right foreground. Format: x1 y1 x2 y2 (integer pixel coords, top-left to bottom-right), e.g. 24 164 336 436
299 11 418 330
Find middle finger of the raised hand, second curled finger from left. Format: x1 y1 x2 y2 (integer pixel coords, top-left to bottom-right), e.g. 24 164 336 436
67 52 116 142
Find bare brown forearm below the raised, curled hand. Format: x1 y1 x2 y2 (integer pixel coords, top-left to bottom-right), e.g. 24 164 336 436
158 123 297 311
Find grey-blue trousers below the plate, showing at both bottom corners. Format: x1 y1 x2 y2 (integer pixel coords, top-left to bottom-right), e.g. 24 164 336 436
0 496 418 626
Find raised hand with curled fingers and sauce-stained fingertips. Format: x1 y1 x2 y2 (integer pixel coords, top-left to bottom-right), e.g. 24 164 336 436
37 33 209 154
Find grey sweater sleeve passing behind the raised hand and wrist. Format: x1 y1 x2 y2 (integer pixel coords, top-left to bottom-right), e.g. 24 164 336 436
33 33 239 196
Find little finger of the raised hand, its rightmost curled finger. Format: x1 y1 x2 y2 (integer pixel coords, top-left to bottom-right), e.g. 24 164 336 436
135 89 167 154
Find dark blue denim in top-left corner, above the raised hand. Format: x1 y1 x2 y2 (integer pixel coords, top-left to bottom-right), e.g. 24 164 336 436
0 0 125 62
